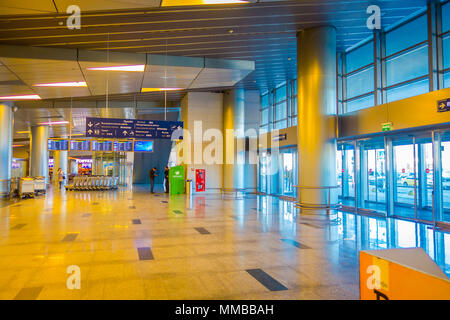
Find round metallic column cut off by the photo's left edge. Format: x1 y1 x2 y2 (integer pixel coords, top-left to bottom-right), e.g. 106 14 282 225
0 103 13 195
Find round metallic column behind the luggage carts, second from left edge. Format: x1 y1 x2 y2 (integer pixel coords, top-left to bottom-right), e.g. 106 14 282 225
30 126 48 183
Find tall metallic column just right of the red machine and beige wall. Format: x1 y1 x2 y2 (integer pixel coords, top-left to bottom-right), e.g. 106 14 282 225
223 89 245 188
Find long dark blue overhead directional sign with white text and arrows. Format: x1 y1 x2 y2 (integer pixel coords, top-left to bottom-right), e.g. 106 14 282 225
86 118 183 140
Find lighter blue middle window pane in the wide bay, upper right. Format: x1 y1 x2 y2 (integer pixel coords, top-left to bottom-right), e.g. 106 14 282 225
386 46 428 86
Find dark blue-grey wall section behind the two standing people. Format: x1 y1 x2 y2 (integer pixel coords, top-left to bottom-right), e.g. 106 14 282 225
133 112 178 184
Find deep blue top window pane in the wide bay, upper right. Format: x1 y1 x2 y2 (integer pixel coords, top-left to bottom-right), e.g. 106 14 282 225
386 15 428 56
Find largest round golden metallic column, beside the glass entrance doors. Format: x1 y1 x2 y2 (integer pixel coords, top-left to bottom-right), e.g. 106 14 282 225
297 26 337 208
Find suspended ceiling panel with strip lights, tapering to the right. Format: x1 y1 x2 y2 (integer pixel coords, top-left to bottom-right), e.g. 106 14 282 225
0 45 254 99
